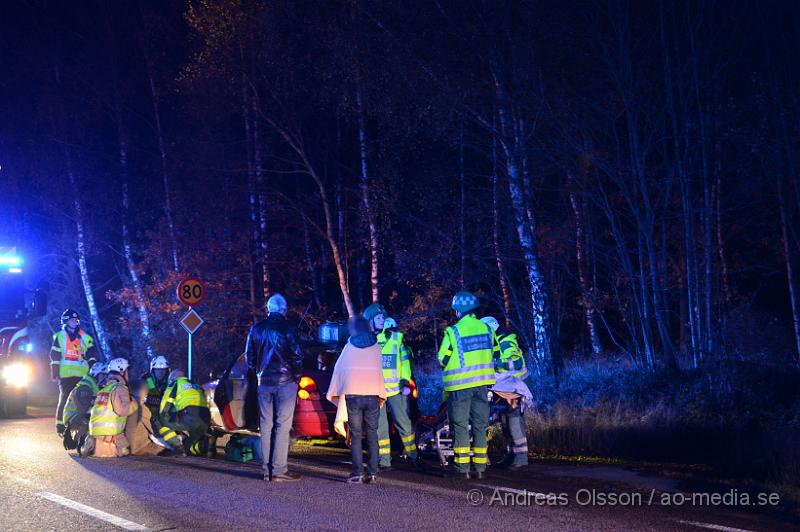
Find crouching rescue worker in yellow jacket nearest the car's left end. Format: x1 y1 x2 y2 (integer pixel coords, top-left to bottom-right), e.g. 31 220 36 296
159 369 211 456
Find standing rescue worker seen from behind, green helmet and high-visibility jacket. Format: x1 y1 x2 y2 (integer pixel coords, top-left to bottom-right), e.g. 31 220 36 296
438 292 499 479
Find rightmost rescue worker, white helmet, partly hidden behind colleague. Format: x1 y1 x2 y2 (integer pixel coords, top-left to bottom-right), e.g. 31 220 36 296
481 316 528 470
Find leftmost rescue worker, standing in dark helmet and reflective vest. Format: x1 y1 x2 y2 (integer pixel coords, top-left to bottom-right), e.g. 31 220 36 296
50 309 97 436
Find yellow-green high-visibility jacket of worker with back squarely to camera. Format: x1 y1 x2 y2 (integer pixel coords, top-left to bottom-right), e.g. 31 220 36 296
439 314 499 392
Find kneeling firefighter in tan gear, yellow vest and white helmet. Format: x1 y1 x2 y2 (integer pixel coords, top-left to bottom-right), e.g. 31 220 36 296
85 358 139 458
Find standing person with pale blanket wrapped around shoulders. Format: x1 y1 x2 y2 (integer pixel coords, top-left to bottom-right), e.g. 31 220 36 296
327 318 386 484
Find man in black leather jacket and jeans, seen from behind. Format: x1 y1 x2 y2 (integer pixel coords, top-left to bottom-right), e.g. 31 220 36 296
245 294 303 482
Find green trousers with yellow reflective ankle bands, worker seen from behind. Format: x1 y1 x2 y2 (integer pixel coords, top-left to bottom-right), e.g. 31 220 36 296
447 386 489 473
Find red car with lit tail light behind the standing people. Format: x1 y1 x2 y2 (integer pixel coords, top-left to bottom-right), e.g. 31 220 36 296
203 322 417 438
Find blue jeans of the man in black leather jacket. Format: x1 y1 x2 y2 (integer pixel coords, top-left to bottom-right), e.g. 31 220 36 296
258 382 297 476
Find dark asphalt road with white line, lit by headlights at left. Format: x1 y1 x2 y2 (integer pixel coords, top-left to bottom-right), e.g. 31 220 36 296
0 414 797 531
